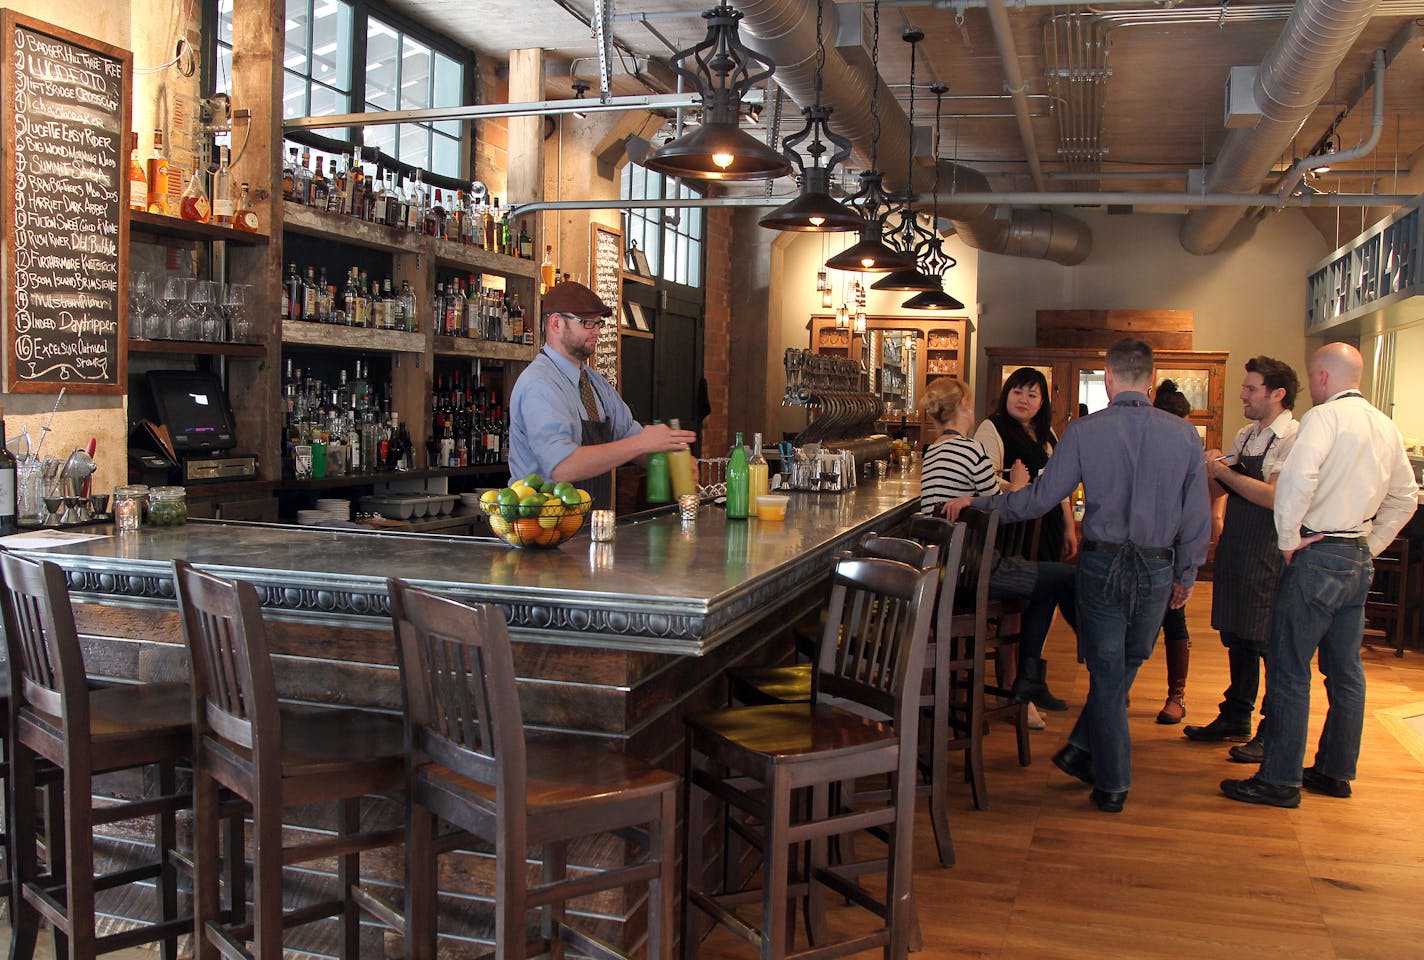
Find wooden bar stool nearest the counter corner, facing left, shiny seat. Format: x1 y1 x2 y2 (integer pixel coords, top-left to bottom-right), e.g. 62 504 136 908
682 558 937 960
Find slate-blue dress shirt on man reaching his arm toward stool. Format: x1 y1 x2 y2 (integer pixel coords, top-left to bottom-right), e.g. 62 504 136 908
974 390 1212 587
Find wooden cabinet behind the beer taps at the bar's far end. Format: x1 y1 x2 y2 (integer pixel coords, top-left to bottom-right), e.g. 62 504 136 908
810 315 971 439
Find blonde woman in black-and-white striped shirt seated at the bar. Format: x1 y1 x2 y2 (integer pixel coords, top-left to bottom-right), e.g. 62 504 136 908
920 377 1077 717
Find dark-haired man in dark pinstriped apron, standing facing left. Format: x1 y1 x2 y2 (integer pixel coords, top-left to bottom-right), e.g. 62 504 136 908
1182 356 1300 763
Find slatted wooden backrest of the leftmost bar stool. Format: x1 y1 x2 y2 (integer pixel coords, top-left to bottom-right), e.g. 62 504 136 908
0 553 90 744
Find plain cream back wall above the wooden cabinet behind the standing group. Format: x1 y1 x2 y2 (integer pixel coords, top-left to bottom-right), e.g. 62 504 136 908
960 209 1327 436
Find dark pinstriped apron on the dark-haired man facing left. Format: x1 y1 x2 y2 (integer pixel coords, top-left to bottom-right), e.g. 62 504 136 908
1212 436 1284 649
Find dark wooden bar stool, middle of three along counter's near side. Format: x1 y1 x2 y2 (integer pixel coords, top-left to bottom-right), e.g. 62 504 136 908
174 560 406 960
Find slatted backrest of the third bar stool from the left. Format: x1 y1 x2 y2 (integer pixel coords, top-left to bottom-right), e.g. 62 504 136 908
387 578 527 800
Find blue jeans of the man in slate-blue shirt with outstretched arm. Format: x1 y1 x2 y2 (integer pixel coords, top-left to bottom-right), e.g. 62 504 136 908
1068 551 1172 793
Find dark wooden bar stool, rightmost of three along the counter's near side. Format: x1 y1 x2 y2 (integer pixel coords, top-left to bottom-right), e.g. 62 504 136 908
390 580 678 960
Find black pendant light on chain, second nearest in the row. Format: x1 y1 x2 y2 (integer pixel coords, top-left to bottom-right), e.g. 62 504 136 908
758 0 860 232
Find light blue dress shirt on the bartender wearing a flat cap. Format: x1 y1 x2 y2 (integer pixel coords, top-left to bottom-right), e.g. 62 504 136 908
510 346 642 479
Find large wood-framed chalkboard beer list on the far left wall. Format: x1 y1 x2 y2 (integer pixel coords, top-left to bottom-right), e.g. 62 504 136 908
0 10 134 393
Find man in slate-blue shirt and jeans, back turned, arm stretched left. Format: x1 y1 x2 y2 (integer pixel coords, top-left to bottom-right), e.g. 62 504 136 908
946 338 1212 813
